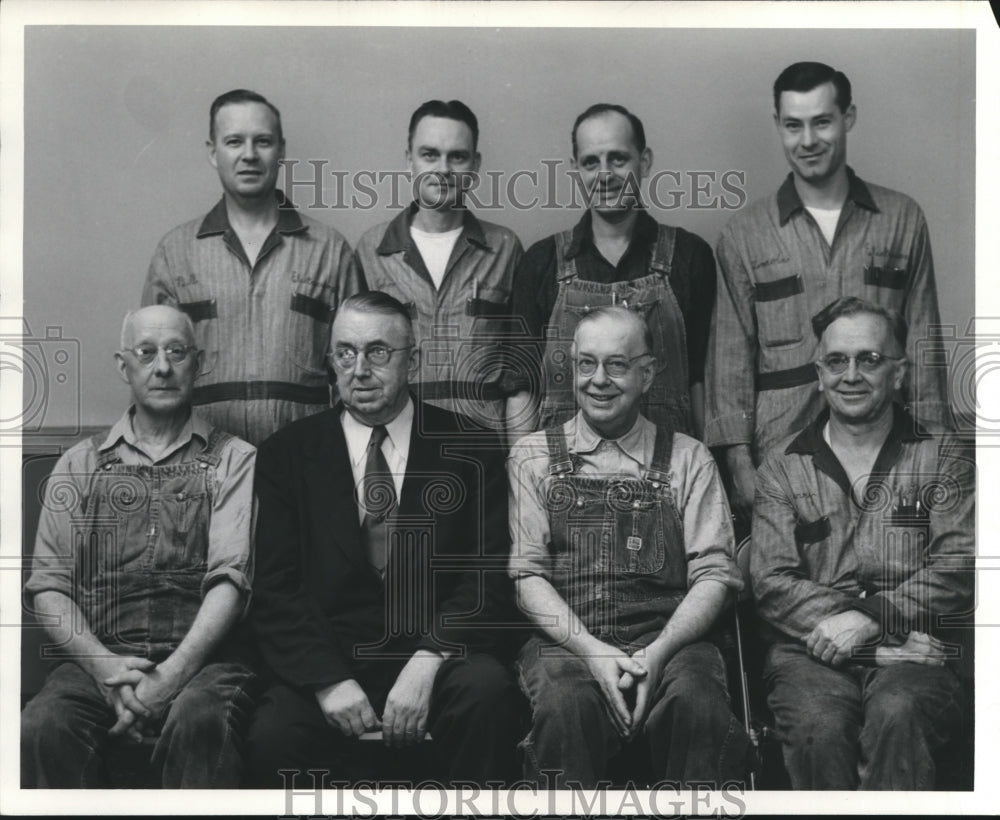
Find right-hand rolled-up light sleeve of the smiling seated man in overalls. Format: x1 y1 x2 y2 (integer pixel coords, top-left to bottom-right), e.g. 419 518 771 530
672 439 743 592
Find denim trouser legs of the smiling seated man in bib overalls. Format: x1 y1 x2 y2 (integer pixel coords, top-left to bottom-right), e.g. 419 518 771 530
517 637 748 789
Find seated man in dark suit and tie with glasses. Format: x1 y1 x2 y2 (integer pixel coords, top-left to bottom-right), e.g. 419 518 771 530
248 292 519 786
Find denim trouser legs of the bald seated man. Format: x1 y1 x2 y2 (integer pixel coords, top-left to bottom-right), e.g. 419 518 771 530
21 662 254 789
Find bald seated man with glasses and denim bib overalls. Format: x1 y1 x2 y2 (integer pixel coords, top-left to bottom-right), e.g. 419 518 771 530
21 306 256 789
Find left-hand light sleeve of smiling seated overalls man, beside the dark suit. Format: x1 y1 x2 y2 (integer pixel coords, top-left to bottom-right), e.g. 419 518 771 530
507 433 551 580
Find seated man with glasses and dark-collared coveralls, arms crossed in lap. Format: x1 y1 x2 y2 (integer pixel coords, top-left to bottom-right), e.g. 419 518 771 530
751 297 975 790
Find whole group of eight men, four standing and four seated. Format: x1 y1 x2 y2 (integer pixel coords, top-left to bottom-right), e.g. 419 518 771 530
21 63 975 789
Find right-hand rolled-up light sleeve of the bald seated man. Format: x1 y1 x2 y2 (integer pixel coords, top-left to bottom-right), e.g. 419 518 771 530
201 439 257 614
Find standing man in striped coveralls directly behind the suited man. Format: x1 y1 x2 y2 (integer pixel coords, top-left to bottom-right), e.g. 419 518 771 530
357 100 522 432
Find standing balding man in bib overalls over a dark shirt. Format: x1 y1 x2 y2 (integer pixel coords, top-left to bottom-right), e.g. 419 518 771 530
507 103 715 446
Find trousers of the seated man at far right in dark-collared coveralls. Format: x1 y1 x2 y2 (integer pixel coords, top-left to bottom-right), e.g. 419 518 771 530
764 644 963 790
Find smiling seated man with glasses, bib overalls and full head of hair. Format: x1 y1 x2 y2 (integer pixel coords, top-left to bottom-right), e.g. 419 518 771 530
507 307 747 788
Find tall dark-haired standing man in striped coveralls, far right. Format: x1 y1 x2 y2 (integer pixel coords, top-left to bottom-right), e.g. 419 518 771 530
705 63 950 515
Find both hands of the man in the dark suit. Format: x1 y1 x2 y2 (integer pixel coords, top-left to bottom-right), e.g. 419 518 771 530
316 649 444 749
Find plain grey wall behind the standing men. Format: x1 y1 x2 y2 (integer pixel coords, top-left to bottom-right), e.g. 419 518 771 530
24 21 976 428
